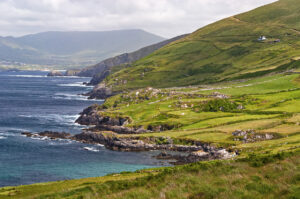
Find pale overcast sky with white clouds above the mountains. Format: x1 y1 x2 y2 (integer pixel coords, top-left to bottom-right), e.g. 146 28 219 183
0 0 276 38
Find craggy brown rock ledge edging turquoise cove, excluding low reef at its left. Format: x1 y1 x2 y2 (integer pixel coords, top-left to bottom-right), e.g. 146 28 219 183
74 132 237 162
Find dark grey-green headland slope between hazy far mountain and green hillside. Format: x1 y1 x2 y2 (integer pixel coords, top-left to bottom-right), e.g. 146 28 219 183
77 35 187 84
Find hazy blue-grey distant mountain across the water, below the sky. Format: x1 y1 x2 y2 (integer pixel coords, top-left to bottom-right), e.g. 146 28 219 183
0 30 164 66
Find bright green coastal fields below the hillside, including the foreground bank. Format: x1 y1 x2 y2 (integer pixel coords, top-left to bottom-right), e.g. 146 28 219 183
0 74 300 199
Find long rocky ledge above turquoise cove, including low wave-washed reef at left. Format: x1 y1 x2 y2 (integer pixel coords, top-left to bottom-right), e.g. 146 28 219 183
22 130 237 164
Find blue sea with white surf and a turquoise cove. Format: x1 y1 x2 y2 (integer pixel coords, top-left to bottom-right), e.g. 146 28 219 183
0 71 168 187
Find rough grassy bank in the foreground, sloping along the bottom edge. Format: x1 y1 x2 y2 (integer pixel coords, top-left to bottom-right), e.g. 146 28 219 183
0 150 300 199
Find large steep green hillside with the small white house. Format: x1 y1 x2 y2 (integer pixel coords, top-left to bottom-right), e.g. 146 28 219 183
106 0 300 91
